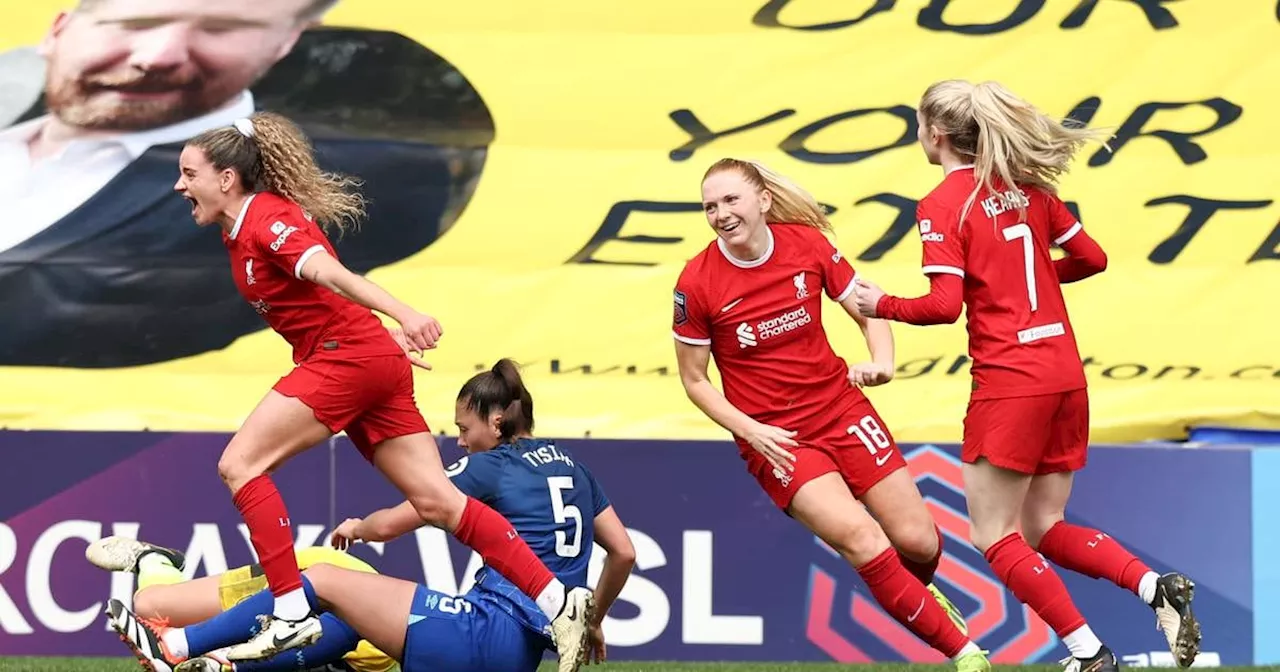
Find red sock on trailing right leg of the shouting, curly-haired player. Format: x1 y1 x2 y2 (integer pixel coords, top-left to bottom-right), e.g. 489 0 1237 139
453 497 556 600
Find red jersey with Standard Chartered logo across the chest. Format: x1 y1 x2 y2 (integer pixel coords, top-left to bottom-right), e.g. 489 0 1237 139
673 224 865 439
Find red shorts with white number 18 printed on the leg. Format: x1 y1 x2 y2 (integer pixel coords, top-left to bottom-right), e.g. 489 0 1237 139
739 402 906 511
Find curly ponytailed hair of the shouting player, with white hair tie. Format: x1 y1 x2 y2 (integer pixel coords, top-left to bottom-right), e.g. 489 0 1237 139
187 111 365 233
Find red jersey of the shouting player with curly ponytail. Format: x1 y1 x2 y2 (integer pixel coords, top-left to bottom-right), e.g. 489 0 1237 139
223 192 402 362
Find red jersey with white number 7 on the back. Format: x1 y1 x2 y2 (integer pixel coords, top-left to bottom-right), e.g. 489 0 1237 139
915 166 1085 399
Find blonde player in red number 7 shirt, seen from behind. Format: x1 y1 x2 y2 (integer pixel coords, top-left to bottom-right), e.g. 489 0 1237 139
855 81 1199 672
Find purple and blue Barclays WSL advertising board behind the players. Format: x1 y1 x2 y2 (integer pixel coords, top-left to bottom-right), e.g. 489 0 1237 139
0 431 1280 666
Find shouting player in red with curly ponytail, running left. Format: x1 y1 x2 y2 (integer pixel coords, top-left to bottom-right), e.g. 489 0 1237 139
96 113 593 671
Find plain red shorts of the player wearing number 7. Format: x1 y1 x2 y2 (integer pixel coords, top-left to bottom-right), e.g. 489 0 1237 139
960 389 1089 475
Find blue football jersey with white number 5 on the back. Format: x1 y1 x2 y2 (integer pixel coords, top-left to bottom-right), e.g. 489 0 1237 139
445 439 609 636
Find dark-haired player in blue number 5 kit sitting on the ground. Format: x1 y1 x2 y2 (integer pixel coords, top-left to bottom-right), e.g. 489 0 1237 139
108 360 635 672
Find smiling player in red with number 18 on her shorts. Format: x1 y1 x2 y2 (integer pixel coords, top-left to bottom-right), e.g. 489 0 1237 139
673 159 991 672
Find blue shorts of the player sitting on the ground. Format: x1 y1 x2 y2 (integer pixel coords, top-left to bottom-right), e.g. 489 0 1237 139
401 585 545 672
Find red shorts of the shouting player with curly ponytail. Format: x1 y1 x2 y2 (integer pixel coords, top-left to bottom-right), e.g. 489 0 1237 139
273 355 430 462
